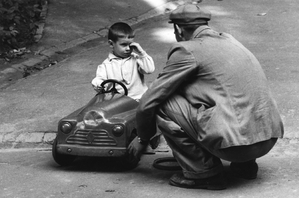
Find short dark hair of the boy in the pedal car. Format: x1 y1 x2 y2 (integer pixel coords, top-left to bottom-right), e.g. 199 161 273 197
108 22 135 42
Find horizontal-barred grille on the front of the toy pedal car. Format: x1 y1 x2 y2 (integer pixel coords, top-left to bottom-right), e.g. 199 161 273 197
66 129 116 146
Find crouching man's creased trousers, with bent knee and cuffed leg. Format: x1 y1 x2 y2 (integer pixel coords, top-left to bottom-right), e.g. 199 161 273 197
157 95 277 179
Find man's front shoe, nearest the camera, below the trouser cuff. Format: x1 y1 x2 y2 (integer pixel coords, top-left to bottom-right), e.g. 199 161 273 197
169 173 226 190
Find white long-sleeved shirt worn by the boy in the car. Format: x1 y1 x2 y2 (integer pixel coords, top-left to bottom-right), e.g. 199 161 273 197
91 52 155 100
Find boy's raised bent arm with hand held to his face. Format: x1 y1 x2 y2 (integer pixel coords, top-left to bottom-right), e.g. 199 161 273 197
130 42 155 74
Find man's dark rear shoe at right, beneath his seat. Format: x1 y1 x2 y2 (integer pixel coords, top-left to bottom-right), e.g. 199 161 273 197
230 160 258 180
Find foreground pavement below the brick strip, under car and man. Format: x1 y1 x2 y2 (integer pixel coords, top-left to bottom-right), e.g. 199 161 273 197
0 146 299 198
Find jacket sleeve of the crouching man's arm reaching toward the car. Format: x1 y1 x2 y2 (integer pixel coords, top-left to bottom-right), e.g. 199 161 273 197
136 43 197 140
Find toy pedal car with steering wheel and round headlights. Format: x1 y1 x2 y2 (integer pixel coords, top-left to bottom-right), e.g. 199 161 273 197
52 79 138 168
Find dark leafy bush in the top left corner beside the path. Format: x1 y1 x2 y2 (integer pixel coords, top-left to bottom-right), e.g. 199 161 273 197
0 0 42 49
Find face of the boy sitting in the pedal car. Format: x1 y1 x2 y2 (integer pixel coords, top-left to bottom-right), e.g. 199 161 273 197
109 37 134 58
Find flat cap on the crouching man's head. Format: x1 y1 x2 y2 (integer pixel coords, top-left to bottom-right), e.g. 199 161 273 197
169 4 211 25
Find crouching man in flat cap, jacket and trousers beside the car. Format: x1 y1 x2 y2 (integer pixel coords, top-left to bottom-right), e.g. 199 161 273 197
129 4 283 190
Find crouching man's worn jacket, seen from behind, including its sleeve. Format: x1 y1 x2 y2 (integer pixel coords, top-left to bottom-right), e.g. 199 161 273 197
136 26 283 149
